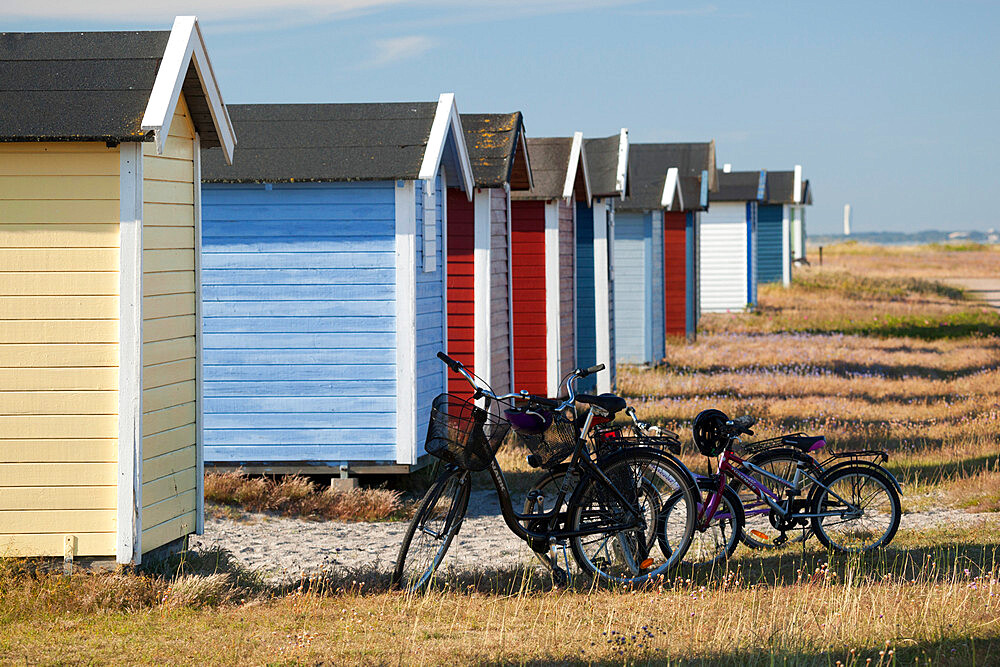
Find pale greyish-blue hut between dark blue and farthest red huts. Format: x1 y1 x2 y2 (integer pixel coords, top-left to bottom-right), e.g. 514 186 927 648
614 144 683 363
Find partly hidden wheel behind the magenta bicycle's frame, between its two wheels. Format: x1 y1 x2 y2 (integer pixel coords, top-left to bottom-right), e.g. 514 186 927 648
730 447 823 549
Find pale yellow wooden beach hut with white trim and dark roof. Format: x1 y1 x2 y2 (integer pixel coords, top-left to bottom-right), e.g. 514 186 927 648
0 17 236 563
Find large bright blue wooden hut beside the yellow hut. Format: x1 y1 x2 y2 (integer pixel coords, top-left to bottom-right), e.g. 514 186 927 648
202 94 473 474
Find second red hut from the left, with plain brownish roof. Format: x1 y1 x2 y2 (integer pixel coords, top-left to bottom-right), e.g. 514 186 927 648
511 132 591 396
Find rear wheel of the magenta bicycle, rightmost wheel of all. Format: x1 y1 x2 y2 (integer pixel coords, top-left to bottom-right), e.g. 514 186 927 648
810 465 902 553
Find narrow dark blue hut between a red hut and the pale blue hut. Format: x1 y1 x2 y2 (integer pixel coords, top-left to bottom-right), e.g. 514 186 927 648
576 128 628 393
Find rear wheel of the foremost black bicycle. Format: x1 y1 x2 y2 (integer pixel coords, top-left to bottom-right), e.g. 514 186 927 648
567 447 698 584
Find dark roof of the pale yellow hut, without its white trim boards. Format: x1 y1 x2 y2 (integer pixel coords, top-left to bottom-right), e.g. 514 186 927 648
0 30 219 146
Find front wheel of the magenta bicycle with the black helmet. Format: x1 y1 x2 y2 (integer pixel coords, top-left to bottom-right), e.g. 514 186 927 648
657 478 743 566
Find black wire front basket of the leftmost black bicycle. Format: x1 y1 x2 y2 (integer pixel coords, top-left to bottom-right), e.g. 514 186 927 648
424 394 510 472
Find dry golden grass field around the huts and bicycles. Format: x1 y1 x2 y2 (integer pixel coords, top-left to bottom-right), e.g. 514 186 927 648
0 245 1000 666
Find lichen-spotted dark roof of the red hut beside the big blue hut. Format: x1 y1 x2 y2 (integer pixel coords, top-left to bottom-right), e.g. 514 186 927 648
461 111 531 190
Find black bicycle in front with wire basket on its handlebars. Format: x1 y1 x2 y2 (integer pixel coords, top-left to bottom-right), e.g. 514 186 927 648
392 352 698 591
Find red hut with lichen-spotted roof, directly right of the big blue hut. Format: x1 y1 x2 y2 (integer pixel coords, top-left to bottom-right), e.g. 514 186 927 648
446 112 531 394
